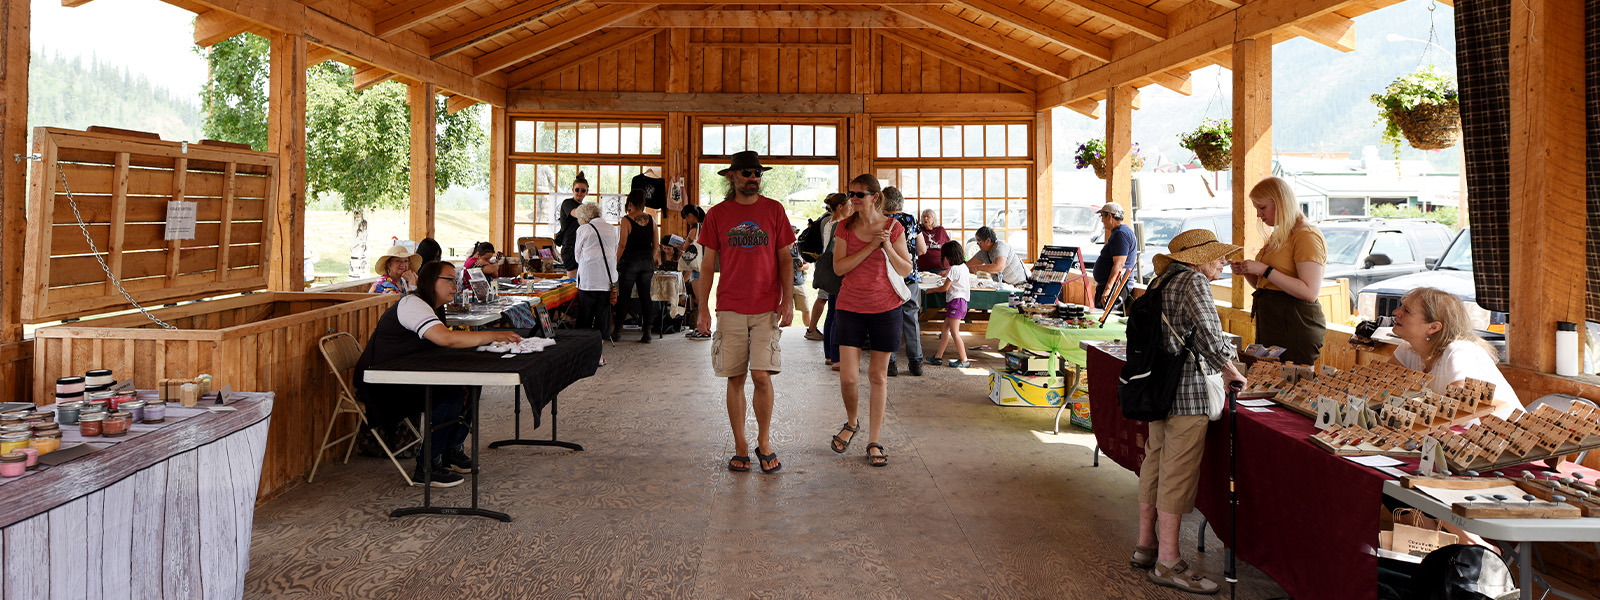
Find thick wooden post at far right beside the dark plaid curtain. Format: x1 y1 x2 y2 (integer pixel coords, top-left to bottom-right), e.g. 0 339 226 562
1507 0 1586 373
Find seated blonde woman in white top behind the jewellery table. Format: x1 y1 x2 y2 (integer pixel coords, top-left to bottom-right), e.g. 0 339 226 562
1389 288 1522 418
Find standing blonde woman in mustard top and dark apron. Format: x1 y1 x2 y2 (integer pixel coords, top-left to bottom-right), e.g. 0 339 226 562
1234 178 1328 365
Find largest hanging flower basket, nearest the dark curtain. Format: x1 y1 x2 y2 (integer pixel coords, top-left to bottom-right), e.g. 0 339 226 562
1371 64 1461 157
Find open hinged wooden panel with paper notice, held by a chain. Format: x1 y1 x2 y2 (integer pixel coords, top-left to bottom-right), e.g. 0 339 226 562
22 128 278 323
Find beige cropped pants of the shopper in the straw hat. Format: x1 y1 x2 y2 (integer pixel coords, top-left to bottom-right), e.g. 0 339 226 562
1139 414 1211 515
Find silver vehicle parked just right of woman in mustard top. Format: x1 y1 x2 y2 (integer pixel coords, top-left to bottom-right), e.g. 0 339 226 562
1317 218 1450 304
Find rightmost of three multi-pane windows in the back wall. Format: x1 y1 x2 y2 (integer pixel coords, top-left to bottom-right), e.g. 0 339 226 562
875 122 1030 254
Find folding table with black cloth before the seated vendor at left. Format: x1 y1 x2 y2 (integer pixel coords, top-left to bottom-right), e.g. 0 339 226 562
363 330 600 522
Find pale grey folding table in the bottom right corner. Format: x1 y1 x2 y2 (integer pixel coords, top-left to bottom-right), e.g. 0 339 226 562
1384 482 1600 600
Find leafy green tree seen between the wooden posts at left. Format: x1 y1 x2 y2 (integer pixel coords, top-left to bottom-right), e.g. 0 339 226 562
202 34 488 278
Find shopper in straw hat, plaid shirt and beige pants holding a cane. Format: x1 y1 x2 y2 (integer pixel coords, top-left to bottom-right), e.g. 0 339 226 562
1130 229 1245 594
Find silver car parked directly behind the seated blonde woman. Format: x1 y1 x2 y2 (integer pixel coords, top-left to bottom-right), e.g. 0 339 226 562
1355 227 1506 333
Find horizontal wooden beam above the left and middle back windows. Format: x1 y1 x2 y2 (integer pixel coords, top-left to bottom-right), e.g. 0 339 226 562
509 90 866 114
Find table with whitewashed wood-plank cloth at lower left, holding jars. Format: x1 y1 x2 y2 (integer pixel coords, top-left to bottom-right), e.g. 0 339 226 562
0 392 274 598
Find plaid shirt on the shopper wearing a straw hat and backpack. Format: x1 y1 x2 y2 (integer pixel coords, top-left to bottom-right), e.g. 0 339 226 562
1162 262 1234 414
